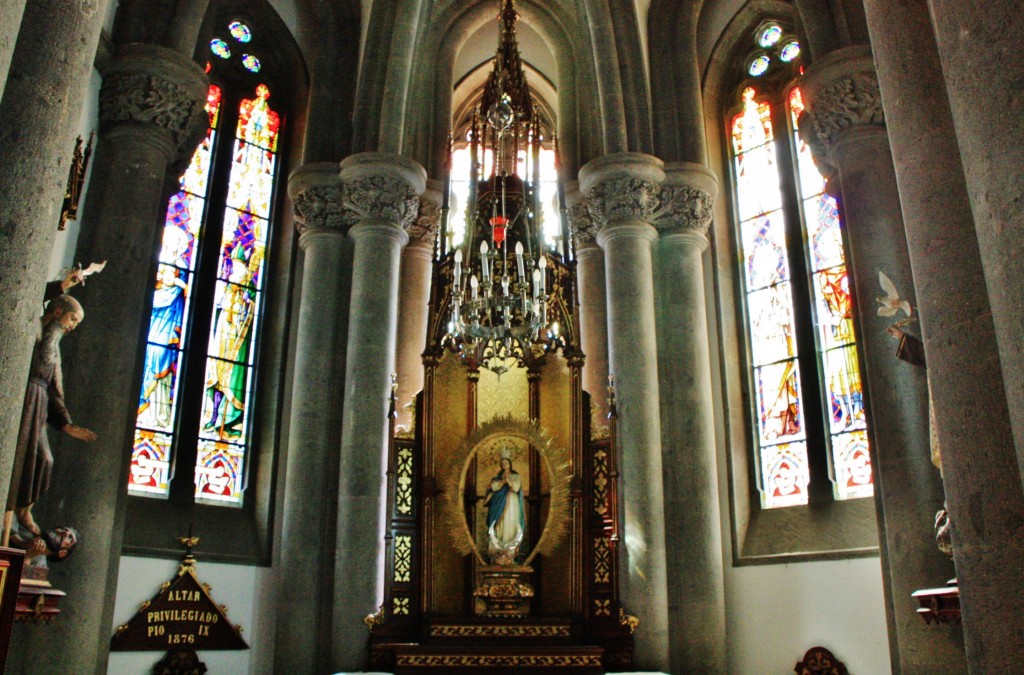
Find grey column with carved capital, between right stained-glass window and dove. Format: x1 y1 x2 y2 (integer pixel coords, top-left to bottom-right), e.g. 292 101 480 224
803 47 951 672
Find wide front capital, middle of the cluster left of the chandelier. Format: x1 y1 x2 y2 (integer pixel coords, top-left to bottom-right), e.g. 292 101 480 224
340 153 427 234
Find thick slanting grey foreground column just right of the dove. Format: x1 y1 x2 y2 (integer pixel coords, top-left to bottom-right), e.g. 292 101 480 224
864 0 1024 673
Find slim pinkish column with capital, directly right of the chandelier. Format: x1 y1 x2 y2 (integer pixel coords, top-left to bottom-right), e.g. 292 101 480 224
566 187 608 438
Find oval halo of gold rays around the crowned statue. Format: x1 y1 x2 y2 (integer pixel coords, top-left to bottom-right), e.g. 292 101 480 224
442 415 572 565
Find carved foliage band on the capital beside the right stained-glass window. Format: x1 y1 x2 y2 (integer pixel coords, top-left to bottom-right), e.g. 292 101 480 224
808 72 886 146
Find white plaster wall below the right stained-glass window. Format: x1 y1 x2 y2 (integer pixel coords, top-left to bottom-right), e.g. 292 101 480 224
725 557 890 675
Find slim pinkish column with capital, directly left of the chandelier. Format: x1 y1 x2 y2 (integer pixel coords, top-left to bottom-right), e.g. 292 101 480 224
395 180 441 433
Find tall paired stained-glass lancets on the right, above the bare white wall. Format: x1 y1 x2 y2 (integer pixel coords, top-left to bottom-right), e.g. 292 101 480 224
729 39 872 508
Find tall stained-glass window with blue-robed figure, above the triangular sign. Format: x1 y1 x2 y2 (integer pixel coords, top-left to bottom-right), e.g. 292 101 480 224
128 19 282 506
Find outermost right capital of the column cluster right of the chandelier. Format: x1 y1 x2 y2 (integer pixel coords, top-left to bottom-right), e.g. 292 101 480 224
652 162 718 236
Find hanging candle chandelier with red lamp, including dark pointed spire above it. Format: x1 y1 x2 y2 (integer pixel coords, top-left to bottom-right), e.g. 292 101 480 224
438 0 568 375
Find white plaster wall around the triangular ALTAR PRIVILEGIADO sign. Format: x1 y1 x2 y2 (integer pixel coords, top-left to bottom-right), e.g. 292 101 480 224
106 557 276 675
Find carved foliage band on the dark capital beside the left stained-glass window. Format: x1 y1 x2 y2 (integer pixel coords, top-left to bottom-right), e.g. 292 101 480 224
99 72 207 150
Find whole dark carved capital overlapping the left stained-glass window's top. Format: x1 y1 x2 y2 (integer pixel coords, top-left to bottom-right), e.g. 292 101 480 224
99 43 210 159
